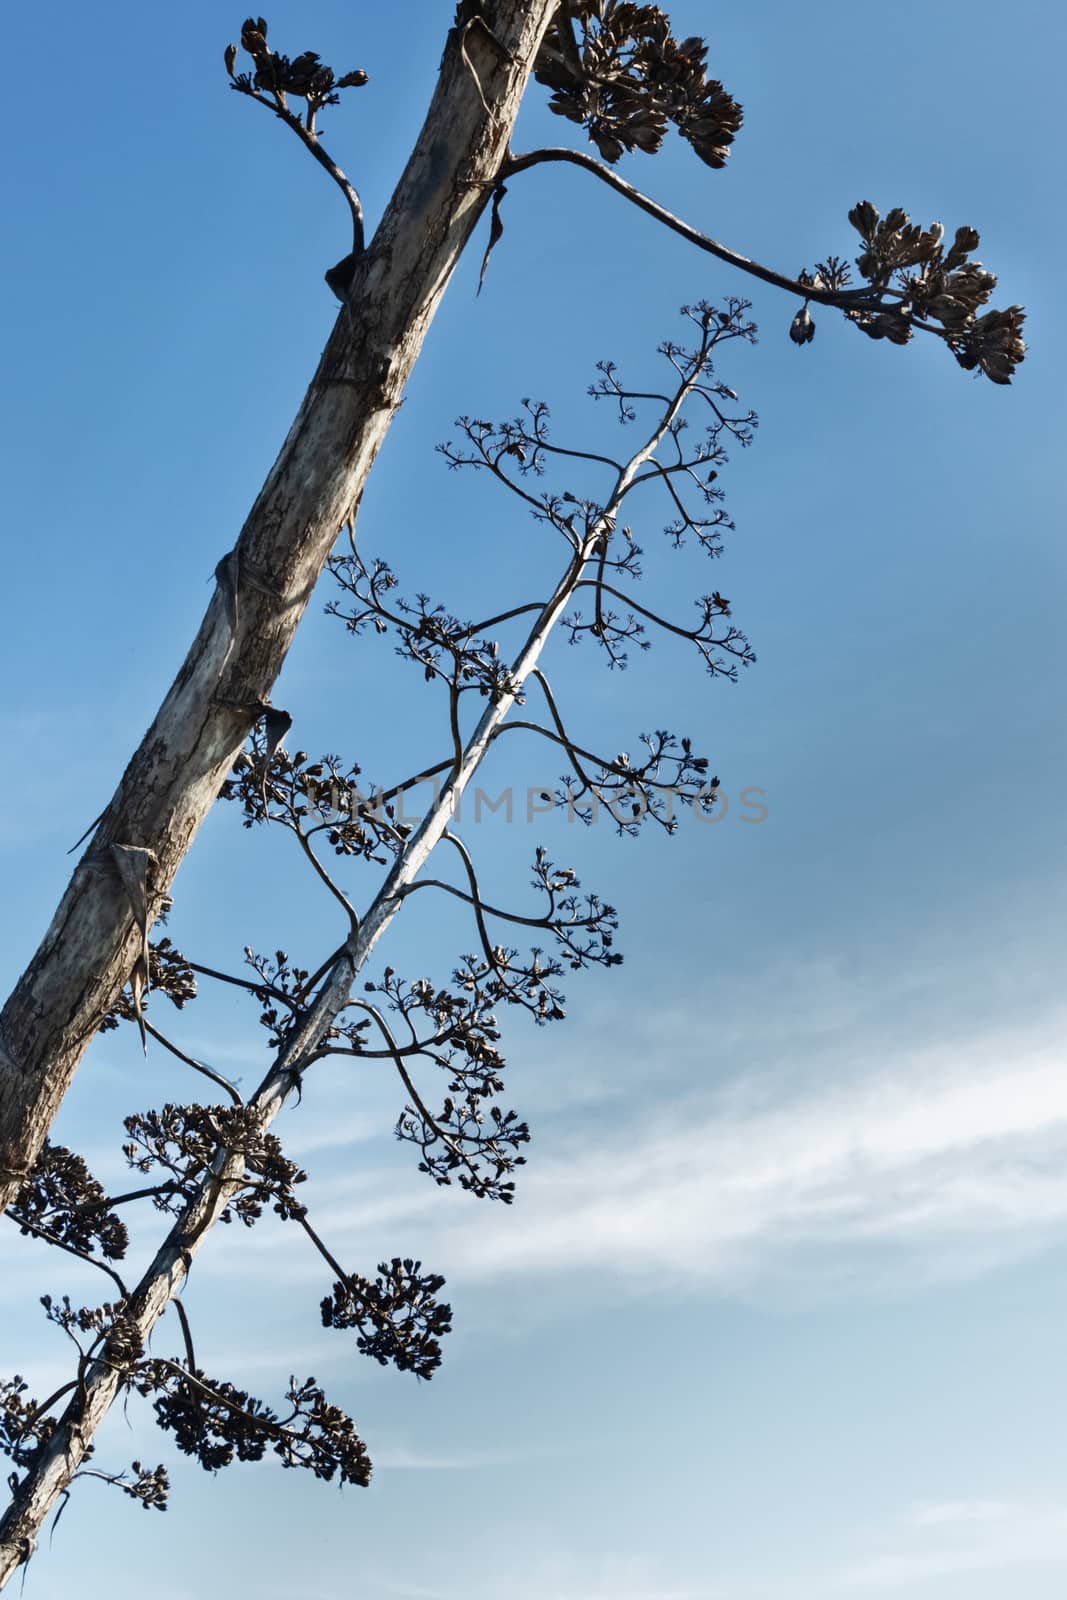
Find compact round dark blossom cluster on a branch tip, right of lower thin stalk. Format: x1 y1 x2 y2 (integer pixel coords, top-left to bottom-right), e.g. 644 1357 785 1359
320 1256 453 1378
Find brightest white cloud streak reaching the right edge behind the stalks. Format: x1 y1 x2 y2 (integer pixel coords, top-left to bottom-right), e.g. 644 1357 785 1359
307 1019 1067 1294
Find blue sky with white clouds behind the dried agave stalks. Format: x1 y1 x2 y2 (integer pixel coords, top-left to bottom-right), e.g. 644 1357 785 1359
0 0 1067 1600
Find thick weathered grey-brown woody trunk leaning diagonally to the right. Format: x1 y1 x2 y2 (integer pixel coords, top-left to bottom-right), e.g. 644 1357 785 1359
0 0 557 1210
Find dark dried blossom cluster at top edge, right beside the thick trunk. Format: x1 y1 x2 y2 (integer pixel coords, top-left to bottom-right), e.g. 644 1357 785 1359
534 0 742 166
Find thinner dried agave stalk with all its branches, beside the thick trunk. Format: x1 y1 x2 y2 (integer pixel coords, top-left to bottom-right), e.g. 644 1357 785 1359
0 299 755 1558
